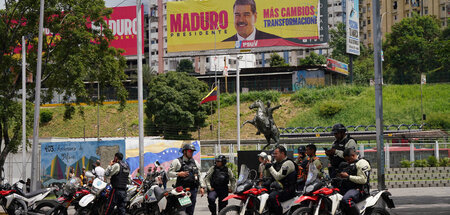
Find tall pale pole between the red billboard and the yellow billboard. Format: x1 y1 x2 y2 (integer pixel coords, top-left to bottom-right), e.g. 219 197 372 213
136 0 144 176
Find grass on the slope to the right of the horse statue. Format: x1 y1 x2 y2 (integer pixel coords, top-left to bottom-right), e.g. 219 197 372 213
288 84 450 129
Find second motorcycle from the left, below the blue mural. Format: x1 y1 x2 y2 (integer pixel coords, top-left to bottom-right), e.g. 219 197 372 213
47 177 90 215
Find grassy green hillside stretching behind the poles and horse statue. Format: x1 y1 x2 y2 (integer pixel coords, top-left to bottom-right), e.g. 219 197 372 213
40 84 450 140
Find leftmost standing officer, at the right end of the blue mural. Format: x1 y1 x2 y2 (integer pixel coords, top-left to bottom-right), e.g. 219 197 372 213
105 152 130 215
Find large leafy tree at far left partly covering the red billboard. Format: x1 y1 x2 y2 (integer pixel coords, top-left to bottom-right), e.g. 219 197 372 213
0 0 127 173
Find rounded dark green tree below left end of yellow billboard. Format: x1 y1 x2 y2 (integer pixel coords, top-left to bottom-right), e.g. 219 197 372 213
145 72 209 139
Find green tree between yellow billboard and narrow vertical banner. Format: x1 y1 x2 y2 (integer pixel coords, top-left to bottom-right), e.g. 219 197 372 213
329 22 349 63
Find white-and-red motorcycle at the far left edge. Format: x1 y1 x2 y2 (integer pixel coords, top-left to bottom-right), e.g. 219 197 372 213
0 180 57 215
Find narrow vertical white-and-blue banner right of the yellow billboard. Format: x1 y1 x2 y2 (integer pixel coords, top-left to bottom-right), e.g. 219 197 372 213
345 0 360 55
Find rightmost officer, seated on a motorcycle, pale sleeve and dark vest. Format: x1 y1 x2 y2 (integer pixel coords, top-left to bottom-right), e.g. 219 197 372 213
338 148 371 215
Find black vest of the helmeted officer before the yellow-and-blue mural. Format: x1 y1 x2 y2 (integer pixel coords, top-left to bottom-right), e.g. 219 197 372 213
175 157 200 189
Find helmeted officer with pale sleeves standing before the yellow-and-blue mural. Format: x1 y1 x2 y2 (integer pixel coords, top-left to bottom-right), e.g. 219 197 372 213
168 143 205 215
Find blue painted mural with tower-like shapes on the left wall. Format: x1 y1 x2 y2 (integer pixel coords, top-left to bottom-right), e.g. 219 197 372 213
41 140 125 185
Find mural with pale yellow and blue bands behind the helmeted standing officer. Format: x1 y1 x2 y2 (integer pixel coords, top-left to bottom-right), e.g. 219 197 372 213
126 139 201 177
